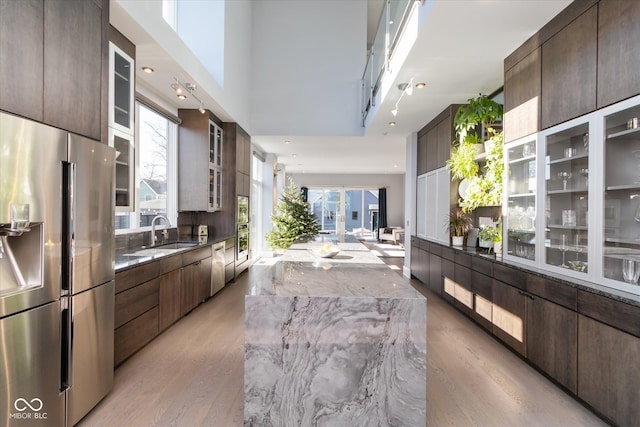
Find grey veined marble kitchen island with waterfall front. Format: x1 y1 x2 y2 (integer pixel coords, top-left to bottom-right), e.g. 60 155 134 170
244 236 427 426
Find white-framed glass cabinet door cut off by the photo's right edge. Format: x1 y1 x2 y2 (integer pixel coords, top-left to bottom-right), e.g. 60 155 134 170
602 100 640 287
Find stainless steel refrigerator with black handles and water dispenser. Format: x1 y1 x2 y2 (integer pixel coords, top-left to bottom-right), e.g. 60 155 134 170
0 113 115 427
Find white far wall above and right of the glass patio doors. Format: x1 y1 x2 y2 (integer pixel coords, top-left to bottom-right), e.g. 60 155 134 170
289 174 405 227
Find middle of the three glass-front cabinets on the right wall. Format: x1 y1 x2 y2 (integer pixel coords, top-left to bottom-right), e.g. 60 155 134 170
544 121 589 277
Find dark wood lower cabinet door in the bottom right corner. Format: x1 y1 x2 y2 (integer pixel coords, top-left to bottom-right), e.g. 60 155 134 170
578 315 640 426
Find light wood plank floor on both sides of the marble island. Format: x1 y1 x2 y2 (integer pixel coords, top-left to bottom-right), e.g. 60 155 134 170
79 258 607 427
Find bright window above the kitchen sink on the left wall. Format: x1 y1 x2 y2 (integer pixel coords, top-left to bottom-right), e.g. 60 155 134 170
115 102 177 232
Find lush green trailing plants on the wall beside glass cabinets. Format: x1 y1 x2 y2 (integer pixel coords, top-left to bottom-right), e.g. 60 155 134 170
447 94 504 212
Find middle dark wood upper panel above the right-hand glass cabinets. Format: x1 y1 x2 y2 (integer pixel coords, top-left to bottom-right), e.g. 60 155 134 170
541 6 598 129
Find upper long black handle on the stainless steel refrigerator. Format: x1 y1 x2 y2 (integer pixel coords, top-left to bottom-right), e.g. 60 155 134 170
61 162 76 295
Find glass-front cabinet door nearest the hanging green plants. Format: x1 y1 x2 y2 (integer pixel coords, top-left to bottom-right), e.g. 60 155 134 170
503 135 537 262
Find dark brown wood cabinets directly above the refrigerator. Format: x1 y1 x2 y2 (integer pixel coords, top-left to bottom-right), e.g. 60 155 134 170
0 0 109 140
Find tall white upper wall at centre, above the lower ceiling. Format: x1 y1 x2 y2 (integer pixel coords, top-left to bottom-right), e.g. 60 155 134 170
249 0 367 136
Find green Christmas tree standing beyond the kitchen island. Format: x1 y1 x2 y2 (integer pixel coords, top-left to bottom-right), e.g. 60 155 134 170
266 182 319 249
